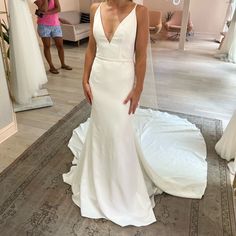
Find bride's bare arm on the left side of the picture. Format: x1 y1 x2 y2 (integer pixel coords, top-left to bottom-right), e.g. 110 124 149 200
83 3 99 104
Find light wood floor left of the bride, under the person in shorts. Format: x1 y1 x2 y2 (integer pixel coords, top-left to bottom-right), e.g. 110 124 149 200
0 44 86 172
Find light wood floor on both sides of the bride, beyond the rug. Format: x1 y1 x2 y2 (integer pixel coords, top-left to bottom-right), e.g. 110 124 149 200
0 39 236 172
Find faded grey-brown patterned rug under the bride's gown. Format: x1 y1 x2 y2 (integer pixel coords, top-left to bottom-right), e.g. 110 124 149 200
0 101 236 236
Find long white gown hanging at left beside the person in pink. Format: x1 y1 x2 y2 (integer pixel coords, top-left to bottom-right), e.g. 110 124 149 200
8 0 47 104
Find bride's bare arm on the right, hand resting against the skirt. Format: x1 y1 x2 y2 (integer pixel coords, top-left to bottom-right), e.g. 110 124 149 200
124 5 149 114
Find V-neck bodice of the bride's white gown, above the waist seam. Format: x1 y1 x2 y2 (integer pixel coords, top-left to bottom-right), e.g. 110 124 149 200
93 4 137 61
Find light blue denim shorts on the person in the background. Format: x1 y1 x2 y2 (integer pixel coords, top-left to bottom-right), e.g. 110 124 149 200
38 25 62 38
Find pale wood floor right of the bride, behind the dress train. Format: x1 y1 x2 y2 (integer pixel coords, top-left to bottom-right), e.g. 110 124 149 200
154 37 236 122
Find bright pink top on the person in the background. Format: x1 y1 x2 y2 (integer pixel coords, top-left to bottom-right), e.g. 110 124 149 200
37 0 60 26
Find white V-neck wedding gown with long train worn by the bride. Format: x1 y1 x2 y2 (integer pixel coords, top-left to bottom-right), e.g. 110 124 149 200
63 3 207 226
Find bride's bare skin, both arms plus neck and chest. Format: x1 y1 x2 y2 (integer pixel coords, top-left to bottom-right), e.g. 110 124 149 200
83 0 149 114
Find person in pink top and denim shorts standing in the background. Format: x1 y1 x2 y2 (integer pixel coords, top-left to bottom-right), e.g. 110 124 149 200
34 0 72 74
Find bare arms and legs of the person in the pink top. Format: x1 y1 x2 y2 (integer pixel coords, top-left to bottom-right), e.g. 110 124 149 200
34 0 72 74
